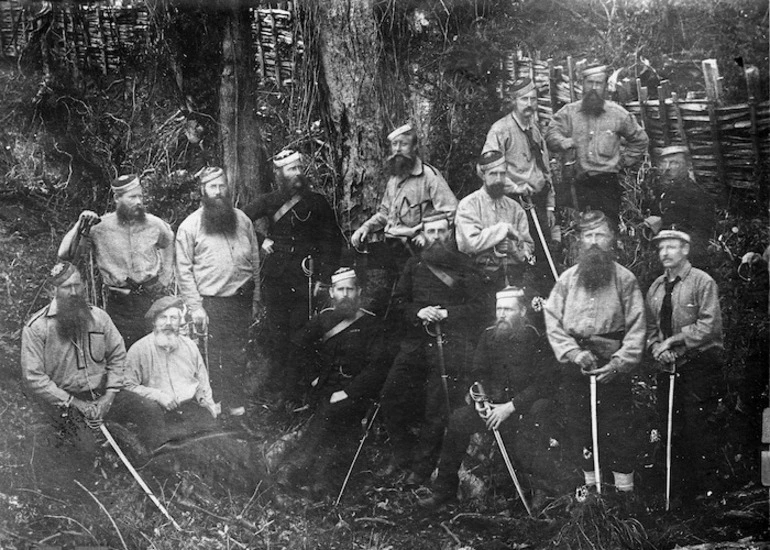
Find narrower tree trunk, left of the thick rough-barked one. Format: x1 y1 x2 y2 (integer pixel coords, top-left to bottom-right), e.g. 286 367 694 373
219 2 270 204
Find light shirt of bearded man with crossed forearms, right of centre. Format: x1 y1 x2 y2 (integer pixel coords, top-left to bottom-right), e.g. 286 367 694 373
455 187 535 268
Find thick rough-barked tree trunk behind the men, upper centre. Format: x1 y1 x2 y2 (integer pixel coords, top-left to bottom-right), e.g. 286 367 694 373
307 0 390 235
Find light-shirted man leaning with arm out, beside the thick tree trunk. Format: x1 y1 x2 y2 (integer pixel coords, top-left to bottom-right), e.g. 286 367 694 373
350 124 457 311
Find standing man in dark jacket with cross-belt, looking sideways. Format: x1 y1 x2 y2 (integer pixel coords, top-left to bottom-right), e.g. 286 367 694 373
244 150 342 401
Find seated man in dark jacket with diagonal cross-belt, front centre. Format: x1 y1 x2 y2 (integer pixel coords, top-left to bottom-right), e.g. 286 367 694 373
281 267 388 496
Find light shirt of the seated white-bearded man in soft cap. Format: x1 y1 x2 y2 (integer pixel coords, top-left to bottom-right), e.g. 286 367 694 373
126 332 214 406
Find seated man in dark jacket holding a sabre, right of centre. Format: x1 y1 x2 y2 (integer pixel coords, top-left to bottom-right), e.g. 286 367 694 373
419 287 558 507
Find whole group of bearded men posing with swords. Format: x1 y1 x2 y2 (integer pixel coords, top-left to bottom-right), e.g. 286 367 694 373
21 66 722 507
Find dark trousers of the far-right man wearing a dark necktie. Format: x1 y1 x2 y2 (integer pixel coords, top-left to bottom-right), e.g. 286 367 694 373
657 350 722 503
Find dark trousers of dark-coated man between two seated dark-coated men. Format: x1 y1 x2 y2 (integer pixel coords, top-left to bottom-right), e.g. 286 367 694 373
380 335 472 474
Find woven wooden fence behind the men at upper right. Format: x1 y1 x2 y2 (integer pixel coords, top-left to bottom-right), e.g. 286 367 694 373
508 51 770 192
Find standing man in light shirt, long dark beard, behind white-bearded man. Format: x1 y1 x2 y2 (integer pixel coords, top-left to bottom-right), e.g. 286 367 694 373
176 167 260 415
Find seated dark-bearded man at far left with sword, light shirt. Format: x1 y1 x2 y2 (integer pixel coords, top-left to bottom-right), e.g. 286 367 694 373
21 262 160 458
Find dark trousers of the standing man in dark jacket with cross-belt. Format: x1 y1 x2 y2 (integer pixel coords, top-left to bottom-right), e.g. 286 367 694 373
262 276 308 399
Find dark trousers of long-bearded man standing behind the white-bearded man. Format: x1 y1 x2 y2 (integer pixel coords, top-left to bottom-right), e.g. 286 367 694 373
203 293 252 407
